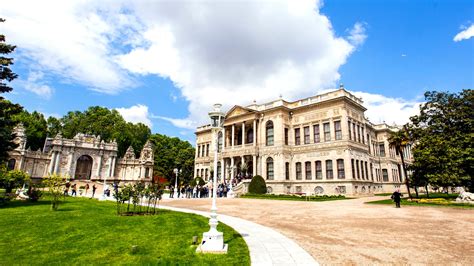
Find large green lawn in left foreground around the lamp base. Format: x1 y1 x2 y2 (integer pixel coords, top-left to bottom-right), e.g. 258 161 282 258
0 195 250 265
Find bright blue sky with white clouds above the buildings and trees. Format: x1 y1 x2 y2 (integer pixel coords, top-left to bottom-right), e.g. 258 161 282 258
0 0 474 144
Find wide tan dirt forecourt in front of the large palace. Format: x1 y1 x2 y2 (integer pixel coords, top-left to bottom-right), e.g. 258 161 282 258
162 197 474 265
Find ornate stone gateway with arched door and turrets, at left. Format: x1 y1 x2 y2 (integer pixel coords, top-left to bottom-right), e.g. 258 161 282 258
7 124 154 183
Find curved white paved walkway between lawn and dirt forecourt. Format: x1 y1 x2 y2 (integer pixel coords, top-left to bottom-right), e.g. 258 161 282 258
160 206 319 265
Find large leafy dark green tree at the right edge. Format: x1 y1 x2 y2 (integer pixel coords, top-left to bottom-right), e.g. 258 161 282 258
409 90 474 191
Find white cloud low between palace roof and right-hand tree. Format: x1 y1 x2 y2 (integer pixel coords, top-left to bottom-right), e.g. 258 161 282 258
352 91 423 125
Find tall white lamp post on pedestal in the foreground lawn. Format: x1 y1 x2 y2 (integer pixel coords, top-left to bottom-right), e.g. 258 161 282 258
197 103 227 253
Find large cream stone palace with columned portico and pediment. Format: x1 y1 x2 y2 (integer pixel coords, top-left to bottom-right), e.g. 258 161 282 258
194 85 411 195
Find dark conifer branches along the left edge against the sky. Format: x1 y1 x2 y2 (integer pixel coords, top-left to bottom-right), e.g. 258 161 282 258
0 18 22 164
